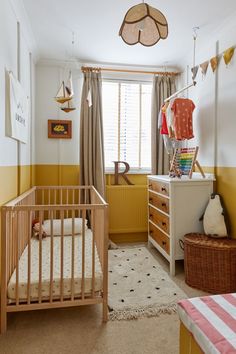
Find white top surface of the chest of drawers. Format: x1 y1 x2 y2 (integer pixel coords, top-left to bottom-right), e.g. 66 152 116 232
148 172 215 183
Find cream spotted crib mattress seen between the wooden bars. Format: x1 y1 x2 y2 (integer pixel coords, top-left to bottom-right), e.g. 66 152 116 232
8 230 103 303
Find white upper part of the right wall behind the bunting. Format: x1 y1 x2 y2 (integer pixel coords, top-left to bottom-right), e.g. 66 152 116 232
185 14 236 167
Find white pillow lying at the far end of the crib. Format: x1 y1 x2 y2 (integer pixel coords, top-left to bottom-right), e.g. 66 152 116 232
43 218 88 236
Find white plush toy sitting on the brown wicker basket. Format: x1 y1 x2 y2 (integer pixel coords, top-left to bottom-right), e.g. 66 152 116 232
203 194 228 237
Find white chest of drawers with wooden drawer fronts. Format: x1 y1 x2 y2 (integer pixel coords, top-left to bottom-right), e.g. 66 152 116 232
148 173 214 275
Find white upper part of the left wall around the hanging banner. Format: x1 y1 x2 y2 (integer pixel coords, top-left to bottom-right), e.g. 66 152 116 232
0 0 36 166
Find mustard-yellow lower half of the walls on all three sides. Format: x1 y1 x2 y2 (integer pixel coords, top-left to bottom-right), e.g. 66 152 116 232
0 165 236 242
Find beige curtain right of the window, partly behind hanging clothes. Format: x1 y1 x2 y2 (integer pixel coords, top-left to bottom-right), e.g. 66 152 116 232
151 76 176 175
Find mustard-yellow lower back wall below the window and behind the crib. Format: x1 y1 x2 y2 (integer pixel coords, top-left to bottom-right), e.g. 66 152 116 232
33 165 147 242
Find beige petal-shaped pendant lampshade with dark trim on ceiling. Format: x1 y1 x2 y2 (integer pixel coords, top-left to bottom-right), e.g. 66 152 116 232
119 3 168 47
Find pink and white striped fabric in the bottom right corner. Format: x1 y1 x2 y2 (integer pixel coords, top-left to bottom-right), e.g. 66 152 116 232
178 293 236 354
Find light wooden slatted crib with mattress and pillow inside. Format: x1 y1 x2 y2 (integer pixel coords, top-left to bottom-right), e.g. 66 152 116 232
0 186 108 333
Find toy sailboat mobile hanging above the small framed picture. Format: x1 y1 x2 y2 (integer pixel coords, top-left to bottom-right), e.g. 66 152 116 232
55 72 75 113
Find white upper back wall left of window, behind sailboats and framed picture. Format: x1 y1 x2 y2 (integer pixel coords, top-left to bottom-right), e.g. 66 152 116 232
35 62 82 165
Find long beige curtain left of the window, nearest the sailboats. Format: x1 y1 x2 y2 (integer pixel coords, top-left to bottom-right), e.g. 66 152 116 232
80 71 105 197
